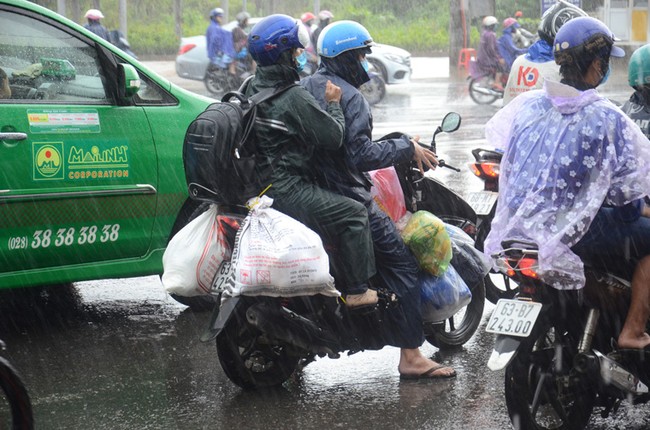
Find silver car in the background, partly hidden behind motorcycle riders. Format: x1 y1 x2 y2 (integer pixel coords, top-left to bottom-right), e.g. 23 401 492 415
176 18 411 84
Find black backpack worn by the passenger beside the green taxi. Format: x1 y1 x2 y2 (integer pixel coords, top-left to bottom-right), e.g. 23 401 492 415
183 81 296 205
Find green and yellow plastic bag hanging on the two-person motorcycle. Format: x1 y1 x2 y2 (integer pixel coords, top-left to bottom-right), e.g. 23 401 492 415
402 211 452 276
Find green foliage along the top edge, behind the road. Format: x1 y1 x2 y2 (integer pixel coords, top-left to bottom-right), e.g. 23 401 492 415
30 0 603 56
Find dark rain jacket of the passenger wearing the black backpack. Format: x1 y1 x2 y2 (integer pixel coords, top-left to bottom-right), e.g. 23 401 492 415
246 65 345 194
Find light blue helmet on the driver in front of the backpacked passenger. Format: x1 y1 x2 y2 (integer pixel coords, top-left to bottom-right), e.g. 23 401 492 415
316 21 374 58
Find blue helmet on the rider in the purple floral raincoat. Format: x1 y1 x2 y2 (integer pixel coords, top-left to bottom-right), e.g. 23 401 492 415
553 16 625 65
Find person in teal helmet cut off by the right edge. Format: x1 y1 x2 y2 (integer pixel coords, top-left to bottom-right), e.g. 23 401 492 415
623 45 650 138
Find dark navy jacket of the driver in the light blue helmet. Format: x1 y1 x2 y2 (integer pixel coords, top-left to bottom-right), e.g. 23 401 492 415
300 67 414 198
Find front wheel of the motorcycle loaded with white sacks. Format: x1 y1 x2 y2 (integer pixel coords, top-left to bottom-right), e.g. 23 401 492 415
425 276 485 349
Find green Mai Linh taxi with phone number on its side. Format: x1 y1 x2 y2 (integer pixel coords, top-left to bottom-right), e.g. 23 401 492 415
0 0 214 306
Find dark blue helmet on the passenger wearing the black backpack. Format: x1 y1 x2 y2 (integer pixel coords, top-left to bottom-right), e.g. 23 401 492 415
248 14 309 66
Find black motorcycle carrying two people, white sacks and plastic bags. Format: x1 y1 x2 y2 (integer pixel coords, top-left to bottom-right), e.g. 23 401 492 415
192 113 485 388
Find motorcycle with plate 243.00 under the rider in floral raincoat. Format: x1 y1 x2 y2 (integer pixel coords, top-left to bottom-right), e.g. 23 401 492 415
486 241 650 430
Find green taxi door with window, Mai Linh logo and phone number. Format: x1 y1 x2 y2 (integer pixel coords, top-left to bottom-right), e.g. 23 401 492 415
0 6 158 283
